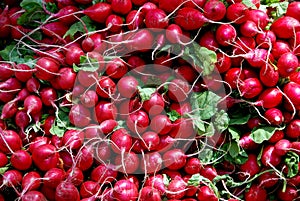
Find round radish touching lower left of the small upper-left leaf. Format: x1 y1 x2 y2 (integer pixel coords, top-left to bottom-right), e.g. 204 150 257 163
55 67 77 91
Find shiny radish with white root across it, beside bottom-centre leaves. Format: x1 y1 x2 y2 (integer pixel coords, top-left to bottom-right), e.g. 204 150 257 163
166 176 187 199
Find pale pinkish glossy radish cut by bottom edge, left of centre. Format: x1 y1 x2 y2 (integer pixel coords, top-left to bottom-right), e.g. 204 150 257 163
113 179 139 201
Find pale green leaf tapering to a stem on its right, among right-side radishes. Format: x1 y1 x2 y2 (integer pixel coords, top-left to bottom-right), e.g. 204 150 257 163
250 126 278 144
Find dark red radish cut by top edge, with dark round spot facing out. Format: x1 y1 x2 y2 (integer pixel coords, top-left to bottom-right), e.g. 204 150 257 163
203 0 226 21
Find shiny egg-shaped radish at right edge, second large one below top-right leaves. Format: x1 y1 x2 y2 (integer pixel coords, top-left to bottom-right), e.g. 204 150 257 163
277 52 299 77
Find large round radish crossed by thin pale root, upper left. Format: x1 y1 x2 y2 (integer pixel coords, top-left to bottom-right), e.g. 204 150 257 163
35 57 60 81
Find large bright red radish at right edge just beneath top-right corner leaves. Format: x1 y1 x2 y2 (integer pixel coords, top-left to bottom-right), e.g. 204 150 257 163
271 16 300 39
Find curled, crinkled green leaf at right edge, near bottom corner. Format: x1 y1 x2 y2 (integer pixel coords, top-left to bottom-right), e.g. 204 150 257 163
284 151 300 178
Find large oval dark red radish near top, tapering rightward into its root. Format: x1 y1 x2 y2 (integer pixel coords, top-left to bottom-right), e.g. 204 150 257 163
174 7 208 31
